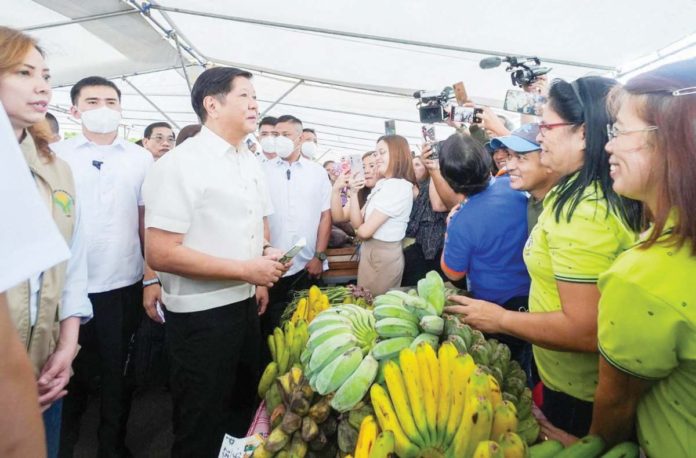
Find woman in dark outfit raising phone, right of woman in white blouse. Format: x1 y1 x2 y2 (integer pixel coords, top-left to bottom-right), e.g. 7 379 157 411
401 152 448 286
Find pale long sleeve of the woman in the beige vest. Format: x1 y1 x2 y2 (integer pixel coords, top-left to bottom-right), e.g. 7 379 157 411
58 190 93 323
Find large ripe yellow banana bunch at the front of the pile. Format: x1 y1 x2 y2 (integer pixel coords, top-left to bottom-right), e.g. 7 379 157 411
370 342 526 458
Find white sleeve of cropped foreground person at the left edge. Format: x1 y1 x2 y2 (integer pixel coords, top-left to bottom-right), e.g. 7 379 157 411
0 103 70 292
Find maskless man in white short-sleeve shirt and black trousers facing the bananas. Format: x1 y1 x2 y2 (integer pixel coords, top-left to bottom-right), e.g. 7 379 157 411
143 67 287 456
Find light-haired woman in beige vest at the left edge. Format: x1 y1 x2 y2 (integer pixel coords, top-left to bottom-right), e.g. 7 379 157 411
0 27 92 456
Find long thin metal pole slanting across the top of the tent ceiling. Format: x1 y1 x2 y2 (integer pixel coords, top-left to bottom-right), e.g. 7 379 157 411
152 5 616 71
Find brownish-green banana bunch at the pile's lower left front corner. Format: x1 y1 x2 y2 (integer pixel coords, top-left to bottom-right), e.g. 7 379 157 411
253 366 338 458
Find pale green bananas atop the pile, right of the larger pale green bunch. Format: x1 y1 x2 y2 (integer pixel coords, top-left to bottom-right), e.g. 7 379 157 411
372 271 445 361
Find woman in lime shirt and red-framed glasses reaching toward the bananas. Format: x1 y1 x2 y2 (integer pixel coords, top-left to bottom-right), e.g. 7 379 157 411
451 77 641 436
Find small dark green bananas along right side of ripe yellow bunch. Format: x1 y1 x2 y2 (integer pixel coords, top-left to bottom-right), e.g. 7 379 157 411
444 315 539 444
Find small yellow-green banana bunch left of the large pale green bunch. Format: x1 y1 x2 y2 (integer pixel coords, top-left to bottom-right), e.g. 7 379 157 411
258 320 309 398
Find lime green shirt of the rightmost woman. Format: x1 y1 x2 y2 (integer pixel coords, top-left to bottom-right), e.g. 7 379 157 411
597 219 696 457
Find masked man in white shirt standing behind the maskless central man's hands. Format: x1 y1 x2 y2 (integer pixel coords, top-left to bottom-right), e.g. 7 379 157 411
261 115 331 361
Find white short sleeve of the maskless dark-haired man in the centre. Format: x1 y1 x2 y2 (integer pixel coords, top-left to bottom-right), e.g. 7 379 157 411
143 153 196 234
